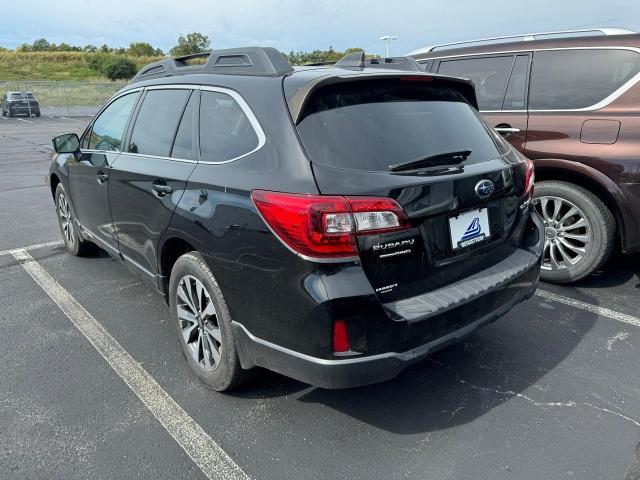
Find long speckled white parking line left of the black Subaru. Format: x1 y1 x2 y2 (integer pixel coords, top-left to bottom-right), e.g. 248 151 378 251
11 249 249 480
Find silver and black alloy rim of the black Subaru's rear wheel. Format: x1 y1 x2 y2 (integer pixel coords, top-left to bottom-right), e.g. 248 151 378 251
176 275 222 370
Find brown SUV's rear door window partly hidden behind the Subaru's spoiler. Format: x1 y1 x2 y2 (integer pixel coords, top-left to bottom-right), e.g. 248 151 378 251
438 55 513 110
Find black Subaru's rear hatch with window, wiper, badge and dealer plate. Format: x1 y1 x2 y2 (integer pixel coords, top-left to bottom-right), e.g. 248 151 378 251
290 74 527 303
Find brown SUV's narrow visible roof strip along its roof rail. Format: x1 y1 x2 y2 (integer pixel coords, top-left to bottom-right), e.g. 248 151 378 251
409 33 640 61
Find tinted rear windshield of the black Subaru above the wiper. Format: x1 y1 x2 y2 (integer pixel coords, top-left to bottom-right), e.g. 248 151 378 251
298 80 508 171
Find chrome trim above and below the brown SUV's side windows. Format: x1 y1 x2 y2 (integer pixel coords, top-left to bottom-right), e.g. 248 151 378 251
418 46 640 113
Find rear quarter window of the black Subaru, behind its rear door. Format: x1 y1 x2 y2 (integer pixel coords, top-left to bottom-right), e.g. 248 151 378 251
200 90 259 162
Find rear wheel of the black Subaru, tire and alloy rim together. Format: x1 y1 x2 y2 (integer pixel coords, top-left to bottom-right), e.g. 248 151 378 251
169 252 248 392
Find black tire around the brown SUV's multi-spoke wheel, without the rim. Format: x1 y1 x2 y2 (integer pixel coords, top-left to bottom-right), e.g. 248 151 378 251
534 181 615 283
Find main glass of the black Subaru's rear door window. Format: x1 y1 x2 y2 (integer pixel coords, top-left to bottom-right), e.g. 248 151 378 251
128 89 191 157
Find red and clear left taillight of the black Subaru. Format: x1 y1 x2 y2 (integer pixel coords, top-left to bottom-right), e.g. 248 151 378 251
251 190 409 260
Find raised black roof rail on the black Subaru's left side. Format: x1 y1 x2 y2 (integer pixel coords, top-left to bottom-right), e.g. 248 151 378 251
131 47 293 83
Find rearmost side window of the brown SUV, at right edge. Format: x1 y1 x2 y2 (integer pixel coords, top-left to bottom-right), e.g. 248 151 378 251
529 49 640 110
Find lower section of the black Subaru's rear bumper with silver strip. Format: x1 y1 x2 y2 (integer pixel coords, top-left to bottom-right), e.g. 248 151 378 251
233 263 540 389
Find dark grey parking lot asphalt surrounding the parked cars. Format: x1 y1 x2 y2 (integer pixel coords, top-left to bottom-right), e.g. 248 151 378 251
0 117 640 480
